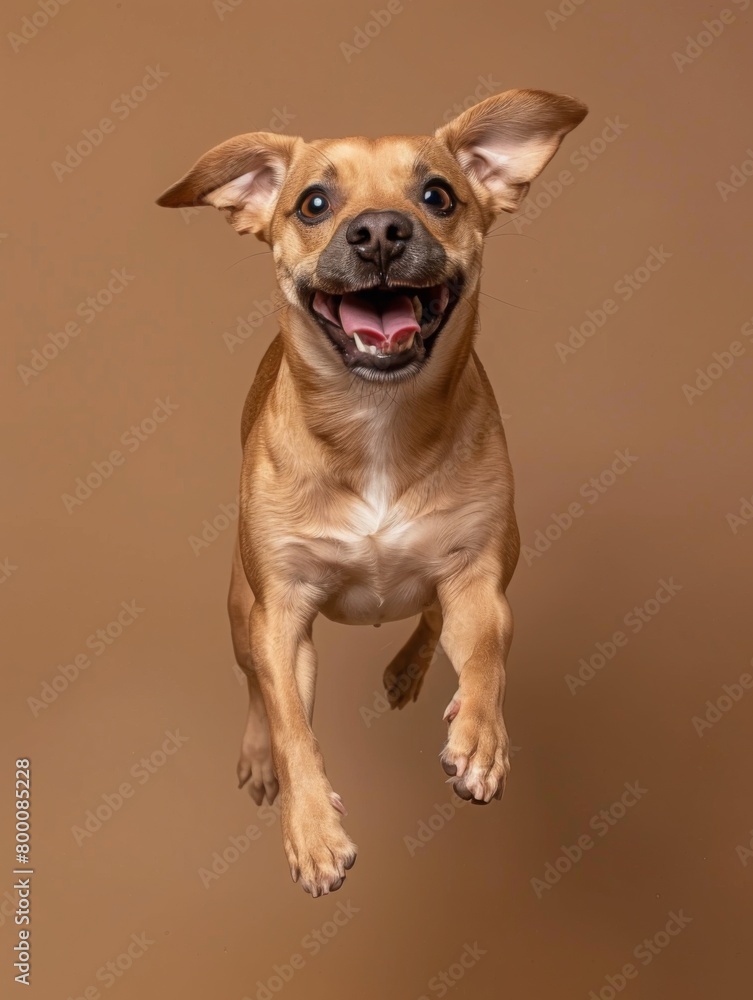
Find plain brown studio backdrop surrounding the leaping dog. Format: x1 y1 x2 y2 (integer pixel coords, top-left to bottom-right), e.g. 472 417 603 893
0 0 753 1000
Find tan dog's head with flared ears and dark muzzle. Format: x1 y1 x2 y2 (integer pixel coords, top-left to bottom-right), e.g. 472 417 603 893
157 90 587 380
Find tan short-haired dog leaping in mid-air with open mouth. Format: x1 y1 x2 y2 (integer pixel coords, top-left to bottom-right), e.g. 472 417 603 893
157 90 588 896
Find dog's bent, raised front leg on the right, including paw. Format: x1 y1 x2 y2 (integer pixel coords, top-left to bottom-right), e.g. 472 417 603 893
438 574 513 803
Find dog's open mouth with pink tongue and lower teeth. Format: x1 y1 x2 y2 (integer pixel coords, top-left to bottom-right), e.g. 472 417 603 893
310 282 460 379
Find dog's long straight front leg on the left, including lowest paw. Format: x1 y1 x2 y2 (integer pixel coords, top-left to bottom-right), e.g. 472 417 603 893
249 603 356 896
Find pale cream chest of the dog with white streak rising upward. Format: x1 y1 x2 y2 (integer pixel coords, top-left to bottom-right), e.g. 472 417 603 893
268 415 493 625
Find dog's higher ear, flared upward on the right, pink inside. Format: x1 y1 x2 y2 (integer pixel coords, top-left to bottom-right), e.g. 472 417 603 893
435 90 588 212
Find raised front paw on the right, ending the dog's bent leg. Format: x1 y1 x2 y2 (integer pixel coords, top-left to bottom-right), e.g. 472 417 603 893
440 695 510 805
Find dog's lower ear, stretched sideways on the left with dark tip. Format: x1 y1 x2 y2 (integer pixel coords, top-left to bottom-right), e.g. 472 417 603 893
157 132 302 241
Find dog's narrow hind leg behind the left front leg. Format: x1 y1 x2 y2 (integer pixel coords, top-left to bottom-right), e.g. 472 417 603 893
227 541 278 806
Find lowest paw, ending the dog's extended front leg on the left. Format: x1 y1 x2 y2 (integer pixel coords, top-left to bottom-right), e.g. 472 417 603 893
282 792 356 896
